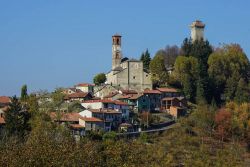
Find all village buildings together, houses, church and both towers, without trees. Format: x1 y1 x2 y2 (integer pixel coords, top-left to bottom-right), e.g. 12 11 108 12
0 21 205 136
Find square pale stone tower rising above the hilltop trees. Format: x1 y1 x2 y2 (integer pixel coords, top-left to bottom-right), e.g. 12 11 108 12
190 20 205 42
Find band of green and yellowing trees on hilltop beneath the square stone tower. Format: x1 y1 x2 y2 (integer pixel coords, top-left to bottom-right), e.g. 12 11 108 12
141 38 250 105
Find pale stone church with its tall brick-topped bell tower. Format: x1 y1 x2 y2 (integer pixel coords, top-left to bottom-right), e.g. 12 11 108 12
106 34 152 91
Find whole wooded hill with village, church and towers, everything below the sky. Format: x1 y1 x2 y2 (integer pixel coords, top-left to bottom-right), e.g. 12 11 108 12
0 20 250 167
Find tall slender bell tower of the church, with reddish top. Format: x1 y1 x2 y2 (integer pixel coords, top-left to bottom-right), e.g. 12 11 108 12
112 34 122 69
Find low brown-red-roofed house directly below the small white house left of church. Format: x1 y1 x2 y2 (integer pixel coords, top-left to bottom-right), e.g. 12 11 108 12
64 92 93 102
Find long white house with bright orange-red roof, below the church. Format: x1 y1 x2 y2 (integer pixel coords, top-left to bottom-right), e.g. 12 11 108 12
81 99 130 120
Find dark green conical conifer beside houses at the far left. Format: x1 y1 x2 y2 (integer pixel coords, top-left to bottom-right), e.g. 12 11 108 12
5 96 30 137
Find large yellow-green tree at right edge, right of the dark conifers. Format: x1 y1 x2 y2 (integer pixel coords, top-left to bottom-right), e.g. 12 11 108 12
208 44 250 103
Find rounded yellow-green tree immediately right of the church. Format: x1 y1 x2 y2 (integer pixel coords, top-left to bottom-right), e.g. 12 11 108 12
149 52 168 86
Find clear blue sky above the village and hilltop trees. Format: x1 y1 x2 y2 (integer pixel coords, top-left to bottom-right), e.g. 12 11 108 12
0 0 250 96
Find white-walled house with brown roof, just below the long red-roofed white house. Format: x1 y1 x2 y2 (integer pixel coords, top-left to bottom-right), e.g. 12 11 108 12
79 109 122 131
